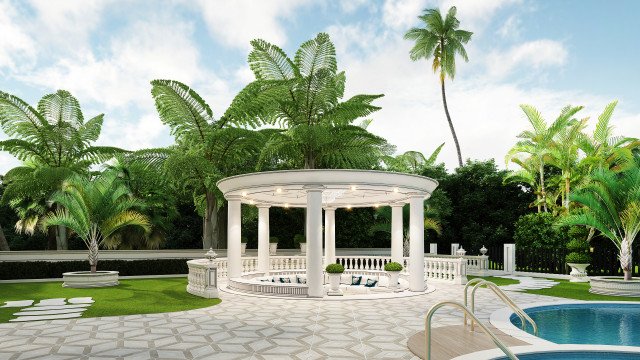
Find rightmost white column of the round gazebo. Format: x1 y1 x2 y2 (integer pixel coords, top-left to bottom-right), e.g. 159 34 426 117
409 194 424 291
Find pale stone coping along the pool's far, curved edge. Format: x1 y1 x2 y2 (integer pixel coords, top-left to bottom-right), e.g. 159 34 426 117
489 300 640 351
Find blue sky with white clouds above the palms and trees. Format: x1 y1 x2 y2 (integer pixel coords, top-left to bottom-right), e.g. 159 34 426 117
0 0 640 174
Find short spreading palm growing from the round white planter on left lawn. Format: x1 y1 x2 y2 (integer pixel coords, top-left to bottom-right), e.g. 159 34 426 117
43 171 150 272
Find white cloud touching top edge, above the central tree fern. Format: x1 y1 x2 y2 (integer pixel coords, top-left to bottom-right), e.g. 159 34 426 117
197 0 307 49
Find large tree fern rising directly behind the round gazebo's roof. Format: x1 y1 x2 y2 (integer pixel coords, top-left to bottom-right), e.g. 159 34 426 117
230 33 391 169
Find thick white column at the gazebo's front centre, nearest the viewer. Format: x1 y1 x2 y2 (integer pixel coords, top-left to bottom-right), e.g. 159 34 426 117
304 186 324 297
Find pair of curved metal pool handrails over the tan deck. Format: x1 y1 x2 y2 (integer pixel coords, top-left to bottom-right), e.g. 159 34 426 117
424 278 538 360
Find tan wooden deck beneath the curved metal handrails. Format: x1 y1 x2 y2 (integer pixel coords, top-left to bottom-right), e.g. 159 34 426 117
407 324 529 360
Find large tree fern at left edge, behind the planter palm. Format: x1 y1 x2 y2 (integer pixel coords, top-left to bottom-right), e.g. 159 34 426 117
0 90 123 249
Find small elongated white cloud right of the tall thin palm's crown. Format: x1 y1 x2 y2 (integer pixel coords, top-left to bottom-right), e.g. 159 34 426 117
485 39 568 78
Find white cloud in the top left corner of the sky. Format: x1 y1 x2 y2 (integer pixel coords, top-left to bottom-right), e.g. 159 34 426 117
0 1 36 71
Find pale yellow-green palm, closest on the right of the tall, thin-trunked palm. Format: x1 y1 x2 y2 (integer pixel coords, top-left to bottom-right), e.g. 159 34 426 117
505 105 582 212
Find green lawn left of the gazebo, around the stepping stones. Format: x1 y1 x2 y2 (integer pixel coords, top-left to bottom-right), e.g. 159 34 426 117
0 277 220 323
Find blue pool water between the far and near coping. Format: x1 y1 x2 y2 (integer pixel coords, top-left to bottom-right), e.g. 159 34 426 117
511 303 640 348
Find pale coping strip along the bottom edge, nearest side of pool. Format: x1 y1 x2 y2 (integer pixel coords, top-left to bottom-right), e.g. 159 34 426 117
452 344 640 360
